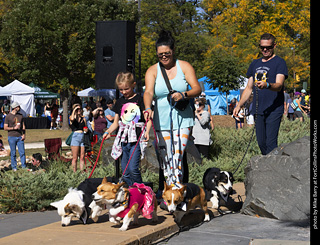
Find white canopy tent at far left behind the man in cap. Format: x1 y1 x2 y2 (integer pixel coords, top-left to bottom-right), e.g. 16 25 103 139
0 80 35 117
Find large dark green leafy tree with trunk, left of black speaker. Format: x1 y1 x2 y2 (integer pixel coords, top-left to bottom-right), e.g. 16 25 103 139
0 0 137 128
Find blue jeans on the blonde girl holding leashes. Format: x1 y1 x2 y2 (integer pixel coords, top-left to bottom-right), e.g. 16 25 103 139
121 142 142 186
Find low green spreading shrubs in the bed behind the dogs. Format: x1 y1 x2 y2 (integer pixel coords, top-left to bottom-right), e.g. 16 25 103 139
0 119 310 212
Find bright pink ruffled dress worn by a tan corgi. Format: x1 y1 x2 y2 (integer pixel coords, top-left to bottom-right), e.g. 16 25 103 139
117 183 155 219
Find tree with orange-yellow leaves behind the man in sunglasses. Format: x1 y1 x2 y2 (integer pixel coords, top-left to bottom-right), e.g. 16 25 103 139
203 0 310 91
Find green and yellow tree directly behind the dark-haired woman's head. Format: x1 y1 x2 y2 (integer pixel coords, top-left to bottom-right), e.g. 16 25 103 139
140 0 207 81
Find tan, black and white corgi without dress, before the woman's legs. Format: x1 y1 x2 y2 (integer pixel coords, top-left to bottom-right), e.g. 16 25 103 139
162 182 210 224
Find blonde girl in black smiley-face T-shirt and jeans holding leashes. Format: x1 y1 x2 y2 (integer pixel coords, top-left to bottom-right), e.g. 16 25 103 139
103 72 151 186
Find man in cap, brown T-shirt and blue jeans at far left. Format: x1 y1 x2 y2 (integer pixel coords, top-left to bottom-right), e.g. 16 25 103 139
4 102 26 171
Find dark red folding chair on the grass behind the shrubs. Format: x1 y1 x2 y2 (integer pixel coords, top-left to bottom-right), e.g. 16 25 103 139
44 138 72 163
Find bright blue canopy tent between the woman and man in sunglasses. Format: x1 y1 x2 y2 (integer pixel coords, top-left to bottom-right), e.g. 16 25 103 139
198 77 240 115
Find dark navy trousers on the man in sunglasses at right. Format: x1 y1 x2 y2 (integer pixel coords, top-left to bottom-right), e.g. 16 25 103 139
256 112 283 155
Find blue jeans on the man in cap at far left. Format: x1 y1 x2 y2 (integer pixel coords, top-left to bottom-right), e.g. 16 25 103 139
8 136 26 169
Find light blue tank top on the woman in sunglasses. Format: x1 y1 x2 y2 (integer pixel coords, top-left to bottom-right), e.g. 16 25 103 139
154 60 194 130
